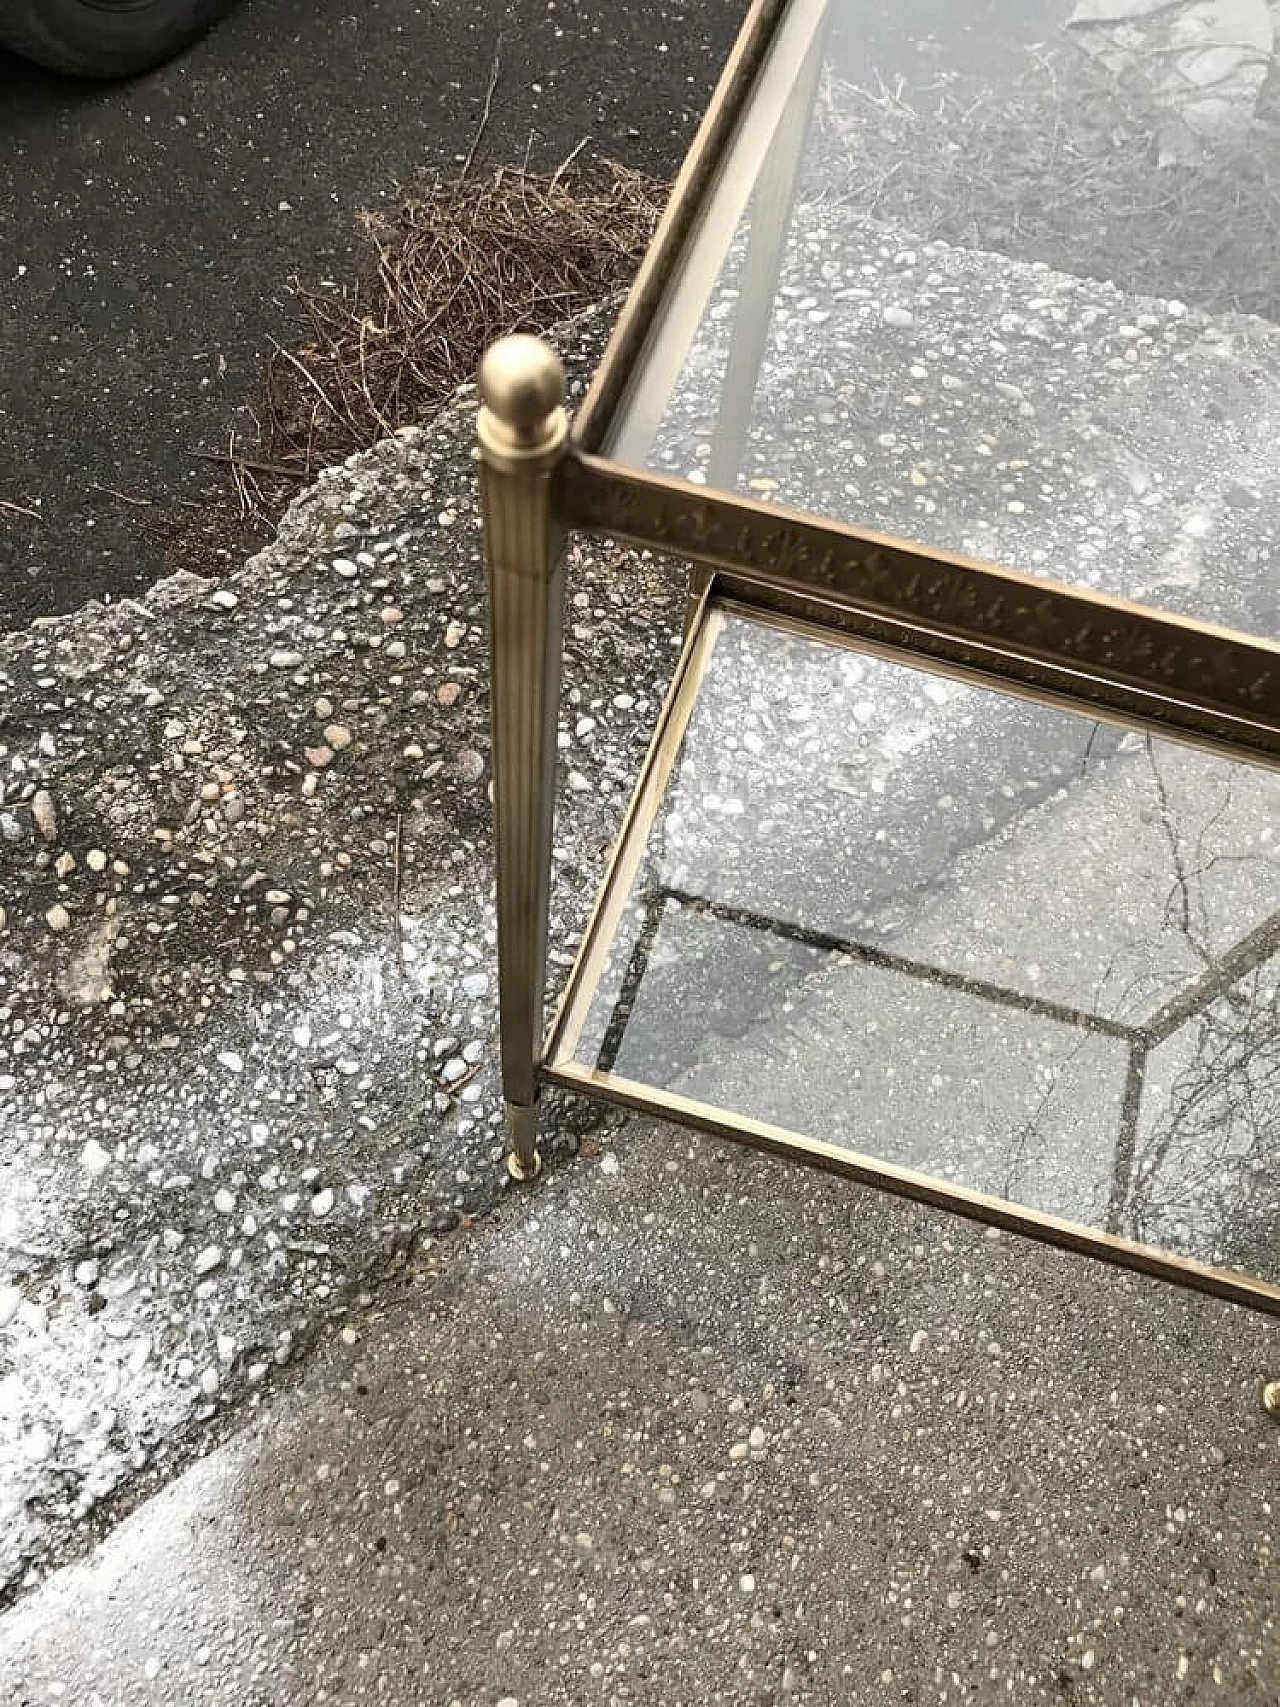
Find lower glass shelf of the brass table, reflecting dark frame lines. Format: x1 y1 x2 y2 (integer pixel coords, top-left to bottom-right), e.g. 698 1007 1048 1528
553 606 1280 1285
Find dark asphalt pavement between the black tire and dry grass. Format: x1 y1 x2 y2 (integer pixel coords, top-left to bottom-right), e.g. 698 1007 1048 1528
0 0 744 626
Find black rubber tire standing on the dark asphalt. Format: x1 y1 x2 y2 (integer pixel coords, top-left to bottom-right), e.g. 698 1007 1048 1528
0 0 236 77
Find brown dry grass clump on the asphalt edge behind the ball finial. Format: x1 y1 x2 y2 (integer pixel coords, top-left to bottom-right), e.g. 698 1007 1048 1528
213 159 664 514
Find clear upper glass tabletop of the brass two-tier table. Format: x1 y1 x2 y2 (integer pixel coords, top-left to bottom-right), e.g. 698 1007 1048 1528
602 0 1280 638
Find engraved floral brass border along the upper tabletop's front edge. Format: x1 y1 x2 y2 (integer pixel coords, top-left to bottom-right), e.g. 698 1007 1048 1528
558 447 1280 765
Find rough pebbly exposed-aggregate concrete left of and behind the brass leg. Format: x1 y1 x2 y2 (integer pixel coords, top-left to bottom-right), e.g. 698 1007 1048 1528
0 303 683 1601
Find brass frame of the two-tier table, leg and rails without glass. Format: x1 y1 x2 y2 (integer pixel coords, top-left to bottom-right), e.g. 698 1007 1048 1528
478 0 1280 1314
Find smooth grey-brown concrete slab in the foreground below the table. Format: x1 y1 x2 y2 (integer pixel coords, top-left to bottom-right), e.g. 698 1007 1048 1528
0 1121 1280 1707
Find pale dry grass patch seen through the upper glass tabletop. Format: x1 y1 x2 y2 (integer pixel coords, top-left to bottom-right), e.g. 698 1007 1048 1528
817 53 1280 321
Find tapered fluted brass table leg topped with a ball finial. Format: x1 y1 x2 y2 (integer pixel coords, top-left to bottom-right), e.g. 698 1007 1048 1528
478 336 568 1180
